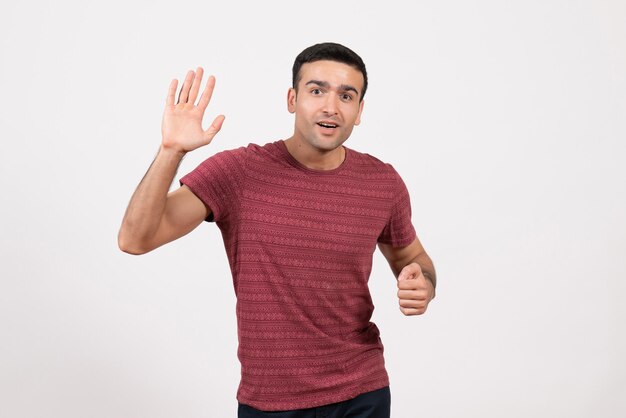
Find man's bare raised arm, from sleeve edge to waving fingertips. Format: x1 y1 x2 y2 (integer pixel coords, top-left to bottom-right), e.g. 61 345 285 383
118 68 224 254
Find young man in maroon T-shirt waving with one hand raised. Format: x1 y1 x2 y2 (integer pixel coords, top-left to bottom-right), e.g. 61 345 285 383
119 43 436 418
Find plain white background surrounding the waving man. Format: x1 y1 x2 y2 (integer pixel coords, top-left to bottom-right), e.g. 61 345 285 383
0 0 626 418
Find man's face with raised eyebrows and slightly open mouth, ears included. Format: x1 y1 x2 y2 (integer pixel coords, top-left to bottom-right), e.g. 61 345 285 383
287 61 364 152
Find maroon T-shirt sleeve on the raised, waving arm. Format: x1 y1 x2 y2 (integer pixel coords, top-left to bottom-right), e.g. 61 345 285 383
180 147 246 222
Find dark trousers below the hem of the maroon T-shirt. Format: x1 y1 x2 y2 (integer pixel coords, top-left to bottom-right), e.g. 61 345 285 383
237 386 391 418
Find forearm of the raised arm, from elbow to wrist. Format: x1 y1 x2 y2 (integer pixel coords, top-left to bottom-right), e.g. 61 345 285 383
118 146 185 253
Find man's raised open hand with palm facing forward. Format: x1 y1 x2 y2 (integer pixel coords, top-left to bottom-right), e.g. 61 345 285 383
161 67 224 153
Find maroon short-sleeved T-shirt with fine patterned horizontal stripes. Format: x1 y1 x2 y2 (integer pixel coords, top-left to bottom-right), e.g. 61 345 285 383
180 141 415 411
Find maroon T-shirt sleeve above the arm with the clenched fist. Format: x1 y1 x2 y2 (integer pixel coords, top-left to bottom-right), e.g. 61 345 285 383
378 170 417 247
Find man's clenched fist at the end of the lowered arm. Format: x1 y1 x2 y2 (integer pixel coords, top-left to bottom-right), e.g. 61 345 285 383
398 263 435 316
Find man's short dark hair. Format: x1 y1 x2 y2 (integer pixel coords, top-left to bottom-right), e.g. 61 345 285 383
291 42 367 101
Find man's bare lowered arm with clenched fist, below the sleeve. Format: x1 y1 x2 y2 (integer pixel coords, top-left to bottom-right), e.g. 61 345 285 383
378 238 437 316
